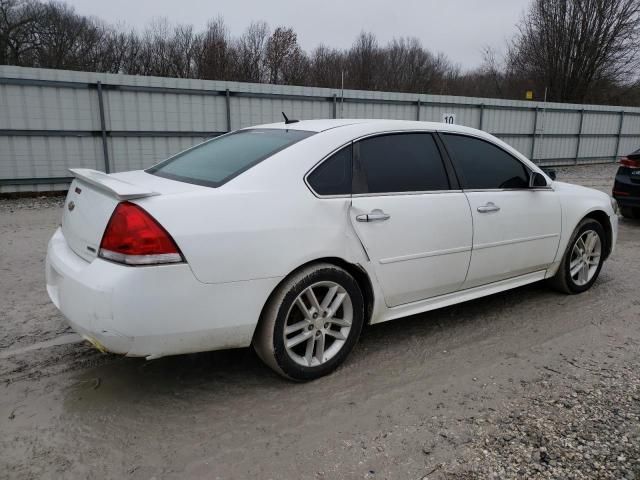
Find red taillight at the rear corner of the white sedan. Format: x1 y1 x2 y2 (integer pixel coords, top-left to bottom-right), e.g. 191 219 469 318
99 202 184 265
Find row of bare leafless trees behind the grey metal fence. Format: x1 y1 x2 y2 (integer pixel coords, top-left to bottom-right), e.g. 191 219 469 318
0 0 640 105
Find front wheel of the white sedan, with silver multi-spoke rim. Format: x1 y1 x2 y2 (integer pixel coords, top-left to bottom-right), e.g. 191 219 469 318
548 218 606 295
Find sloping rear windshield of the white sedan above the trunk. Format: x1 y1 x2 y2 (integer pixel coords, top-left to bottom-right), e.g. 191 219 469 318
147 128 314 187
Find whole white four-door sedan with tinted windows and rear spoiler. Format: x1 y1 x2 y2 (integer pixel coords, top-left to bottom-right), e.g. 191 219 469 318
46 120 617 380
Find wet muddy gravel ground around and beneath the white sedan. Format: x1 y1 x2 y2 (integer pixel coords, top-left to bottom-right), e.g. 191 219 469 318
0 165 640 479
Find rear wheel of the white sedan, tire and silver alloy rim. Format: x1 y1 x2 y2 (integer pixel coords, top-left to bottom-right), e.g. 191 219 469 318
253 263 364 381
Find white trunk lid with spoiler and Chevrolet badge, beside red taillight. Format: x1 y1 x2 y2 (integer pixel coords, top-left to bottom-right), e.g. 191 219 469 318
62 168 193 262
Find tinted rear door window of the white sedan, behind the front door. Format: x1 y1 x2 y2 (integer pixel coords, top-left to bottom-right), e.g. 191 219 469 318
354 133 449 193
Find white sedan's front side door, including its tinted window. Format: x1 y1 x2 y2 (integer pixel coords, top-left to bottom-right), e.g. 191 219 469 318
441 134 561 288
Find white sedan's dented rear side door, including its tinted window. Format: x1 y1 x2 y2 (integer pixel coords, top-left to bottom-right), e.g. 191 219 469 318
350 132 472 307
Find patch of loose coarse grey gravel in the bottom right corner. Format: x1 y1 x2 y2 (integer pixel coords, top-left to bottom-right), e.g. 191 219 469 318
445 356 640 480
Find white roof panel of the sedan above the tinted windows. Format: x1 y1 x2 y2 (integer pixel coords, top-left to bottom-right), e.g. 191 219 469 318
248 118 479 133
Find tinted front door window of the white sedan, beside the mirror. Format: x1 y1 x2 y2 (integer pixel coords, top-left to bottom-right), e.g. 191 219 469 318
442 134 529 190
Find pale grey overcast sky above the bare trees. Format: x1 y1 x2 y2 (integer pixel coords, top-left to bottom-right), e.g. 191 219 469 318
67 0 529 69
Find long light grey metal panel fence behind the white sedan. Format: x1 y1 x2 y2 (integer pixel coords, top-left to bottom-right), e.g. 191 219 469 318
0 66 640 193
